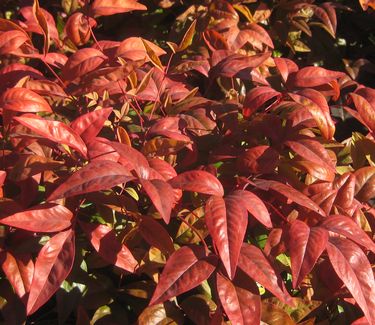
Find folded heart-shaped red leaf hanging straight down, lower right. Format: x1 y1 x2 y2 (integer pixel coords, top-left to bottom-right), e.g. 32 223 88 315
288 220 328 288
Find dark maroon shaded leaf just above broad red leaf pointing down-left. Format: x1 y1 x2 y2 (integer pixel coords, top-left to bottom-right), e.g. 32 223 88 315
139 216 175 255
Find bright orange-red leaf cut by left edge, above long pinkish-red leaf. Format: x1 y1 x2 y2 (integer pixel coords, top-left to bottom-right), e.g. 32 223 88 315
0 88 52 113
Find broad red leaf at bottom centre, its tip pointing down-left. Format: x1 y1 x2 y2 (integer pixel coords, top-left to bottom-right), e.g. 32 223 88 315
150 246 217 305
